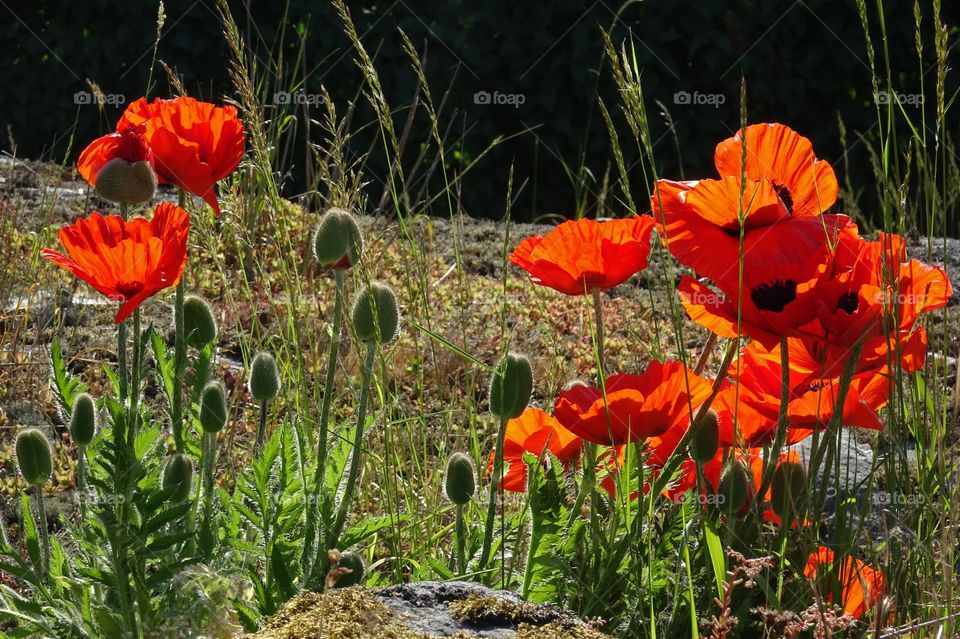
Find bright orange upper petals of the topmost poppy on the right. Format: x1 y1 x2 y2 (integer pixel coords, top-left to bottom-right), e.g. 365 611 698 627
713 123 837 217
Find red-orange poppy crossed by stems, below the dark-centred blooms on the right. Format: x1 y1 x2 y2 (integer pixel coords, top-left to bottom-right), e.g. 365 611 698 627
714 339 890 448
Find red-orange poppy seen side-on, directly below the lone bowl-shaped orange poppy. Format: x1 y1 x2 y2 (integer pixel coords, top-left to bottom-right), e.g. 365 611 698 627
553 361 711 446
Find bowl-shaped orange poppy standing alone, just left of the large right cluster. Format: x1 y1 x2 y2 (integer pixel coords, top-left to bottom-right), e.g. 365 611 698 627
510 215 653 295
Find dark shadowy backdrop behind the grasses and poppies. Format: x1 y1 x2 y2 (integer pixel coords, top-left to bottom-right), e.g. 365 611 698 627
0 0 958 225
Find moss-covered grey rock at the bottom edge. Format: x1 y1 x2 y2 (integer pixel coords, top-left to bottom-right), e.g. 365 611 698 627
248 581 608 639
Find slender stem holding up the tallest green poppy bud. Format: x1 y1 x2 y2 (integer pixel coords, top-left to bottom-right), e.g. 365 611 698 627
300 269 344 581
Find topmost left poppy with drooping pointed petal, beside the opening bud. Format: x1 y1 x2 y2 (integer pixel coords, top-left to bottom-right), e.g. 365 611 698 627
117 97 246 215
